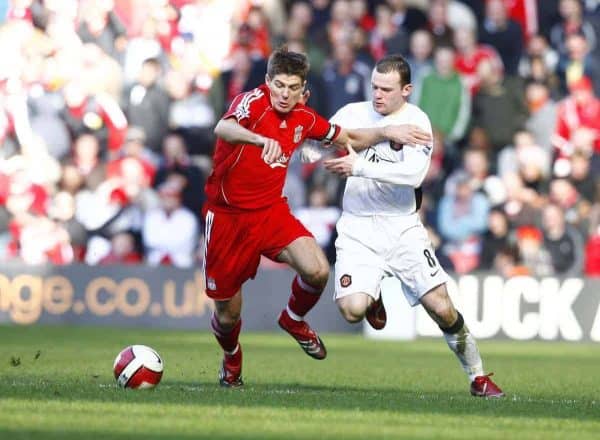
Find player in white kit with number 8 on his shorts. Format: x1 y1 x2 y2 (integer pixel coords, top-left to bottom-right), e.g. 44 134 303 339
324 55 504 397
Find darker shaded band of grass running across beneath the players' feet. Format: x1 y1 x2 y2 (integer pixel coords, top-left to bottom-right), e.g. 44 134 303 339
0 381 599 422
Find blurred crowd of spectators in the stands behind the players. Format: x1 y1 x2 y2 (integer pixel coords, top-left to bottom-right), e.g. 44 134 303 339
0 0 600 277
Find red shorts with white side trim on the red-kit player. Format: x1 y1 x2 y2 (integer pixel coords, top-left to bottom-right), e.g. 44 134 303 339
203 203 312 300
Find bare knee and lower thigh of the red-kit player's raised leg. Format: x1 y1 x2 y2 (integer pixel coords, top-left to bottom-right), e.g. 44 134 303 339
277 237 329 278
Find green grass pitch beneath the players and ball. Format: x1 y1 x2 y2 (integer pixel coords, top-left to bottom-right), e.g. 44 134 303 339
0 326 600 440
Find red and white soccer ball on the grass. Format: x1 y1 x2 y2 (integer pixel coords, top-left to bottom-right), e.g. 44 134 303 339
113 345 164 389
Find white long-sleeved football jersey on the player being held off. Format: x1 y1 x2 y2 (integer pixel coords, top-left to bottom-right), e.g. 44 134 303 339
331 101 433 216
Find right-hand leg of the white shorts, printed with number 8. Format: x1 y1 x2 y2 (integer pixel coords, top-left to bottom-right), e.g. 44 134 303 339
387 225 448 306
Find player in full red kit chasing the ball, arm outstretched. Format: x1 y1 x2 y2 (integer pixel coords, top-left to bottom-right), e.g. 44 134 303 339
203 48 430 387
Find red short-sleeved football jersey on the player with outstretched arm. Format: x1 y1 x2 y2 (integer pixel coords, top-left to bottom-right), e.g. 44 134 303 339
205 85 339 211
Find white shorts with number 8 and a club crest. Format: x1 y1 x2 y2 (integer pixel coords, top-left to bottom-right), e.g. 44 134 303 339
335 213 448 306
